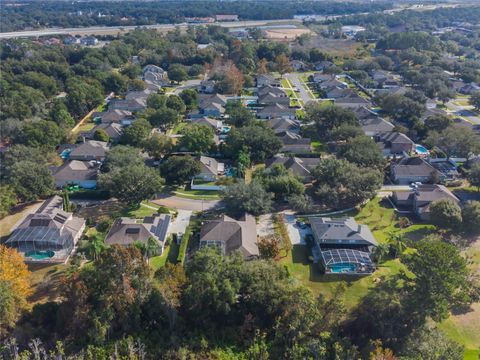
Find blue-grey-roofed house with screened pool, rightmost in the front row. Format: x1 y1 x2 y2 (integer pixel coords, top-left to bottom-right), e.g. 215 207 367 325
310 217 377 275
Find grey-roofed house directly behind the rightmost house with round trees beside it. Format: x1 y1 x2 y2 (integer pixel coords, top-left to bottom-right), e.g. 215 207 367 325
391 157 445 185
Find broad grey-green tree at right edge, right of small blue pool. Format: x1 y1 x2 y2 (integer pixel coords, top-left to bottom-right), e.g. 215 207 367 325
425 125 480 159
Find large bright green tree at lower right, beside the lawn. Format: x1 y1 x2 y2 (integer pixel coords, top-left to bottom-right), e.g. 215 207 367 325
401 239 478 321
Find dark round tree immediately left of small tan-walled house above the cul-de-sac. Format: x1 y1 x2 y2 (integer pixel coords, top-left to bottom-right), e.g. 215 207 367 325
160 156 201 184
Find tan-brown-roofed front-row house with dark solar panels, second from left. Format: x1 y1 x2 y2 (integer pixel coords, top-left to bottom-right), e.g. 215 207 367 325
105 214 170 255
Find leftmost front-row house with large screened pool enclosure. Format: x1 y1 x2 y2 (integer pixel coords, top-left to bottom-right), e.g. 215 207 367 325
5 195 85 263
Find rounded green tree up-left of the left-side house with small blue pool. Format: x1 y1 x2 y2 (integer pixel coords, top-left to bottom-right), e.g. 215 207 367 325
16 120 65 149
